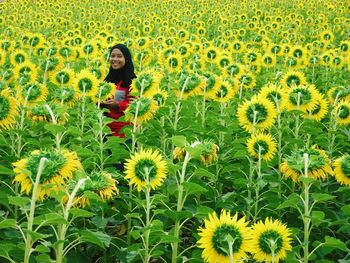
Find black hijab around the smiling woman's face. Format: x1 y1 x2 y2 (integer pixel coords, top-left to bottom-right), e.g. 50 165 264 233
105 44 136 88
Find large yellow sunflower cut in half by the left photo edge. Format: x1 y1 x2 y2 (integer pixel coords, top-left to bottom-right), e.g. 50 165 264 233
0 89 18 129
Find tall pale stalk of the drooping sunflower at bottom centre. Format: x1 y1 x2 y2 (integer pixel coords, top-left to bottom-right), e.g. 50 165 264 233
171 151 191 263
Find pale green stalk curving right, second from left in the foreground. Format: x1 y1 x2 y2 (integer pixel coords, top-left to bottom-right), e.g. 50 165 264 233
55 178 87 263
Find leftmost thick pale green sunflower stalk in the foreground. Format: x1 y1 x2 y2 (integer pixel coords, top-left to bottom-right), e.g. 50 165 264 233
23 157 47 263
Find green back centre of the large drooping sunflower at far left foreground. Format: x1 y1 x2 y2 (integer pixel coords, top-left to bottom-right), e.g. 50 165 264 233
27 152 66 183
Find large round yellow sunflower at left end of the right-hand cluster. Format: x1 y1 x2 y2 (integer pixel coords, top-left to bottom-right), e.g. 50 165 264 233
237 96 277 132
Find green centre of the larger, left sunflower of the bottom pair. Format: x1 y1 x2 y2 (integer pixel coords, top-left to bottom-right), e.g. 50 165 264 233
211 224 243 256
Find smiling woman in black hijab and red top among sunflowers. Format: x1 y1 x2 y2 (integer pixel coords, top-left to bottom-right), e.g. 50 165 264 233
102 44 136 138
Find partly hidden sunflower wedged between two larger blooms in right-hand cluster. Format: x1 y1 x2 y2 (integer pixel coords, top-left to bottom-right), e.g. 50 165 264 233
259 83 287 112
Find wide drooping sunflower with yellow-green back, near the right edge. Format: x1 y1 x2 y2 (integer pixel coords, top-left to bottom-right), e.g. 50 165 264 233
279 147 333 182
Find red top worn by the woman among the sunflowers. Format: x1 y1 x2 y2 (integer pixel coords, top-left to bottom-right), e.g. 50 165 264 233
107 81 130 138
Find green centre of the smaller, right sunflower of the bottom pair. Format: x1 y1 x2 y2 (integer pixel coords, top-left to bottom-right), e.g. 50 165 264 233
259 230 283 255
